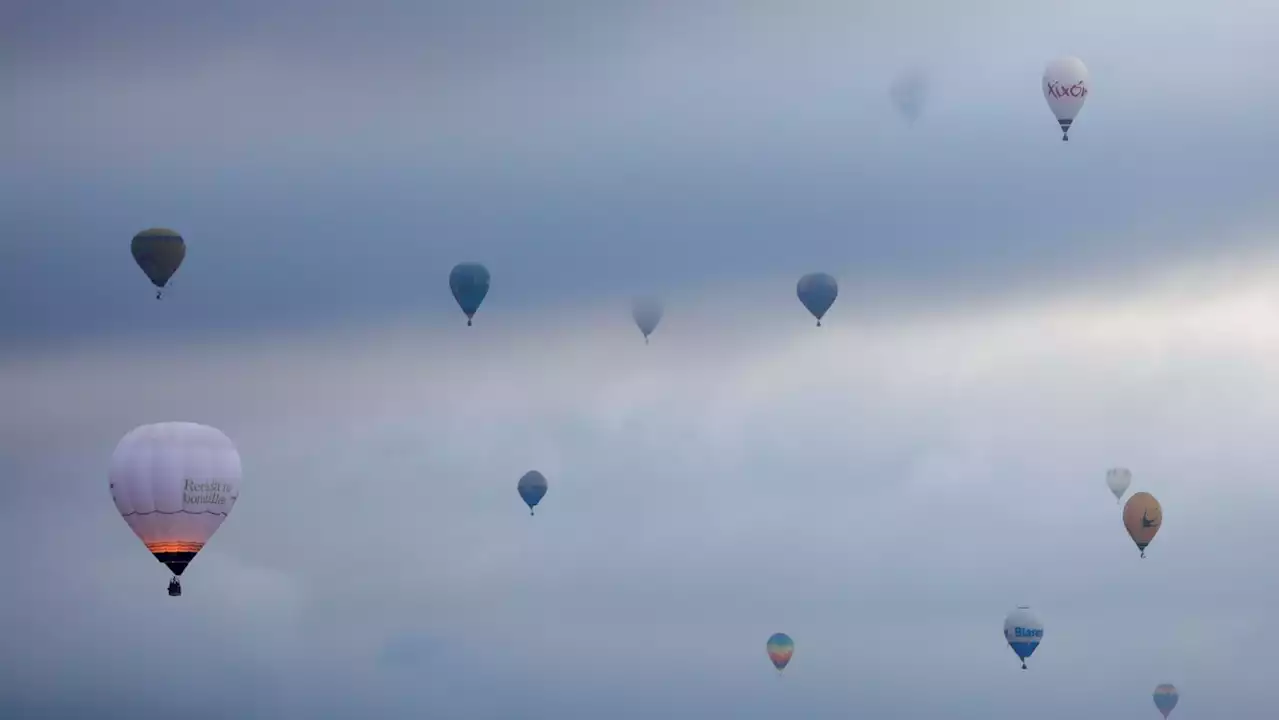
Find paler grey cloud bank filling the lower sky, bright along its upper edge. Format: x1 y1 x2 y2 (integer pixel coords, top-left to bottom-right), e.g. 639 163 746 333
0 266 1280 719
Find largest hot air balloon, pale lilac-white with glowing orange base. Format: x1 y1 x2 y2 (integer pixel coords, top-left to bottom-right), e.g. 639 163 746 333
109 423 241 597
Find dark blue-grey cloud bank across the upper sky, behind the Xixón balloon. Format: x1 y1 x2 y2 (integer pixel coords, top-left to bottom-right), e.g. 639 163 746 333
0 3 1277 342
